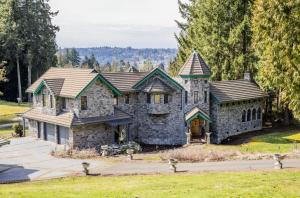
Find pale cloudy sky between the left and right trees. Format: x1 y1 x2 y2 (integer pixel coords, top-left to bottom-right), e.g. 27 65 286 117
49 0 184 48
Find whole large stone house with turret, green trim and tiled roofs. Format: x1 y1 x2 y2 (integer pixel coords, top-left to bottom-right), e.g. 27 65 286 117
23 52 266 148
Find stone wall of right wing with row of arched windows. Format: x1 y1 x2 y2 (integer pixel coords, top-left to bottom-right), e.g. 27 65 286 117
210 100 264 143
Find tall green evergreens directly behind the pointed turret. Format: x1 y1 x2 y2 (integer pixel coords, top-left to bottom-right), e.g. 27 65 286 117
170 0 255 80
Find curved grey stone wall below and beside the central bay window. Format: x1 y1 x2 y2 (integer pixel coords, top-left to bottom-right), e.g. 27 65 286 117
137 92 186 145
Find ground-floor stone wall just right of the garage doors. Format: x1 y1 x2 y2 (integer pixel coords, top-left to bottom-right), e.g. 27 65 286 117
70 124 115 149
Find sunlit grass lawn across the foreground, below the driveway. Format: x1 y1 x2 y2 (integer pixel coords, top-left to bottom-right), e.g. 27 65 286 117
0 170 300 198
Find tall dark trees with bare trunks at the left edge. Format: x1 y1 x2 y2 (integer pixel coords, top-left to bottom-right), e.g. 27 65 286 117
0 0 59 101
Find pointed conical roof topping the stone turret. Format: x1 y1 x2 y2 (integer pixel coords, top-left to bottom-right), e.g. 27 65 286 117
178 51 210 78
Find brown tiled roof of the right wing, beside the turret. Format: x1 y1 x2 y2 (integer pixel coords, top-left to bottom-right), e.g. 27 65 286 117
210 80 268 103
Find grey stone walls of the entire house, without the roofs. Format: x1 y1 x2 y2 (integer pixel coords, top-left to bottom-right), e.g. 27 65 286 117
29 66 263 149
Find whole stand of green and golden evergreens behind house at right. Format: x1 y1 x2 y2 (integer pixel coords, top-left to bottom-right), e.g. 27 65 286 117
169 0 300 124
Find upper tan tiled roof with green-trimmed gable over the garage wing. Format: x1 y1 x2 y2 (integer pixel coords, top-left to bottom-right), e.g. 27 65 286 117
26 67 121 98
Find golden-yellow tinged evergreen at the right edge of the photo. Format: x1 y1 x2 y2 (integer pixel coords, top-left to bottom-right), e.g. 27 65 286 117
252 0 300 121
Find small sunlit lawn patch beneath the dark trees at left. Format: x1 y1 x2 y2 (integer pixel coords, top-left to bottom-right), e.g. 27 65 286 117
0 100 29 124
